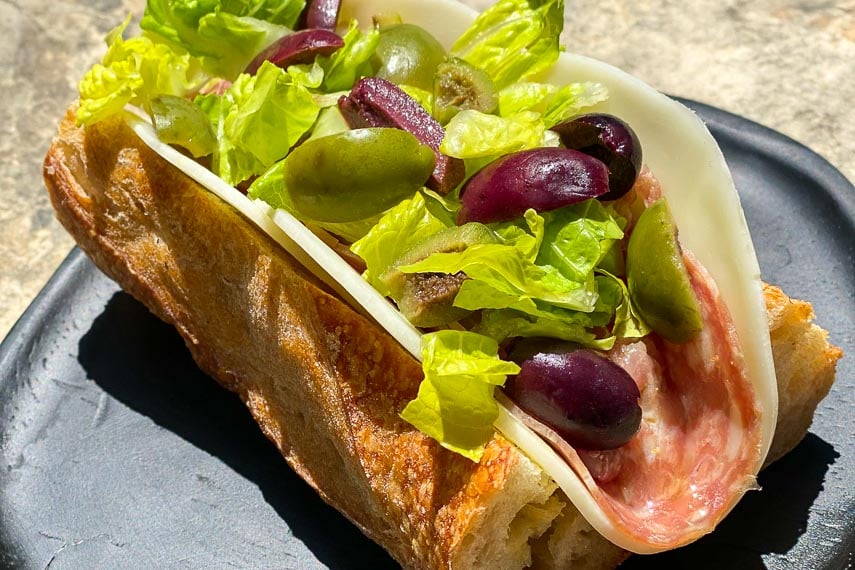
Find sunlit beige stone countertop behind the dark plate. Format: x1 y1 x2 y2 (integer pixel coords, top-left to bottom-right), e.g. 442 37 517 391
0 0 855 338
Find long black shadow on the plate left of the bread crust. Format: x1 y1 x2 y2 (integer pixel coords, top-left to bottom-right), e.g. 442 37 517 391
79 293 397 569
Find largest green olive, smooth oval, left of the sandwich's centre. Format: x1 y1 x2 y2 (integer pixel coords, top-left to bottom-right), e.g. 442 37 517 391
283 128 435 222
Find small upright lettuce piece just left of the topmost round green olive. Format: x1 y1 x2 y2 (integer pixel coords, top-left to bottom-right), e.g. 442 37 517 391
318 20 380 91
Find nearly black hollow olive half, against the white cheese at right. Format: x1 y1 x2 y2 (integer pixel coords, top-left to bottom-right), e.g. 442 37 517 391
552 114 641 200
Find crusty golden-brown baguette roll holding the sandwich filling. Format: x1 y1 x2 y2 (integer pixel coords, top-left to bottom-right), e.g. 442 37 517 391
44 108 840 569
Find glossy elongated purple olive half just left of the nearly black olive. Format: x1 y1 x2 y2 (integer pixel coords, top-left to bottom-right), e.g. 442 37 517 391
457 148 609 224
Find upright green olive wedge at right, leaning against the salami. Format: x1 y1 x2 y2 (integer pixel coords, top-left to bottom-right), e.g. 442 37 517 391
626 198 703 343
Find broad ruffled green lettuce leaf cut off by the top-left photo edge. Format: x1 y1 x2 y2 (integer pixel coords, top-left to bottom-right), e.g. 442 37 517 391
140 0 305 79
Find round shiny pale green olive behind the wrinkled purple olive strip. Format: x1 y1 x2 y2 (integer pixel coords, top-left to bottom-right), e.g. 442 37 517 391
374 24 445 91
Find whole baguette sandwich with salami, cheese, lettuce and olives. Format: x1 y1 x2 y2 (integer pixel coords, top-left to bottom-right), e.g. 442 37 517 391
45 0 840 568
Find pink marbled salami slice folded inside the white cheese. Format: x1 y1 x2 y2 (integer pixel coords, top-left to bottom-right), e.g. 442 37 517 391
502 254 761 549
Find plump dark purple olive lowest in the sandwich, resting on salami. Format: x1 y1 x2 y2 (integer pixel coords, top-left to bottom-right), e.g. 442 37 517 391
505 342 641 450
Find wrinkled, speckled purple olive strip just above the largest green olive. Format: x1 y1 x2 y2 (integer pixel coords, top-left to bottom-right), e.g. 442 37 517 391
338 77 465 194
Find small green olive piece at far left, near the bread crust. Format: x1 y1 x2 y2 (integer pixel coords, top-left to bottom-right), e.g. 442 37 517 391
148 95 217 158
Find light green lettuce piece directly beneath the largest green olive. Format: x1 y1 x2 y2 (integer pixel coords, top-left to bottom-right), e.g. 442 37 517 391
350 193 448 296
